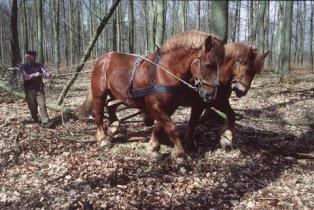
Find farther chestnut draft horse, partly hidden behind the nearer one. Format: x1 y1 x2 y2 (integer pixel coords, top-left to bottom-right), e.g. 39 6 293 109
209 43 269 148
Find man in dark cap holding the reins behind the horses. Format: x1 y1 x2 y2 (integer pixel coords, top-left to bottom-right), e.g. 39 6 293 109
20 50 52 128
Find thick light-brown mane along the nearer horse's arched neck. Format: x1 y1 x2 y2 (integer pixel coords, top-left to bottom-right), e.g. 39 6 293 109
160 31 210 54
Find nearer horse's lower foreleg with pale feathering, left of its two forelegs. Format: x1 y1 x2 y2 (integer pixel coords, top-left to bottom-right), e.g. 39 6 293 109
147 122 163 159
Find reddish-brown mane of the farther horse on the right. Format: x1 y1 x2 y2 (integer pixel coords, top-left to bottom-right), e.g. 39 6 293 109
225 42 264 74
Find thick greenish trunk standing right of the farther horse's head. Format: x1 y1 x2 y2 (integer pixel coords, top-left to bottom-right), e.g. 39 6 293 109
280 1 293 82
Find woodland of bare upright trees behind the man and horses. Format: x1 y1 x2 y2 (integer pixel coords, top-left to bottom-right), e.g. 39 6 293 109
0 0 314 79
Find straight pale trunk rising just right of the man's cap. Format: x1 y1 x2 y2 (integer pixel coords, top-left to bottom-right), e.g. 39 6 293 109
37 0 45 64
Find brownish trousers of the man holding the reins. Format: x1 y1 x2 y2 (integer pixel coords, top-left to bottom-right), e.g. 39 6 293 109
24 88 49 123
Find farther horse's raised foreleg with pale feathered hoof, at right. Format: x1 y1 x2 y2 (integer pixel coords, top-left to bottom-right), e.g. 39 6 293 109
220 100 235 149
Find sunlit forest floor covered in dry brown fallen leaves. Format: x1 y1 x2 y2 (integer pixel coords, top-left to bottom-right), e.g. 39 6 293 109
0 70 314 210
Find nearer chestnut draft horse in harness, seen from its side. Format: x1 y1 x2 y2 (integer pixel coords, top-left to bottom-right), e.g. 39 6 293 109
91 31 224 161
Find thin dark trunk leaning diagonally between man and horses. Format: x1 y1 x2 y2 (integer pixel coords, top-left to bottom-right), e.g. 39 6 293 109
57 0 120 105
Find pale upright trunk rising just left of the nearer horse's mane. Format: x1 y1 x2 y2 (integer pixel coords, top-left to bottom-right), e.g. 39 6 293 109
155 0 165 46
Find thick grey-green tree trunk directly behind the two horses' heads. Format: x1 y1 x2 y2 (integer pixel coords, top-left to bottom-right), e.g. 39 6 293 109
211 0 228 40
